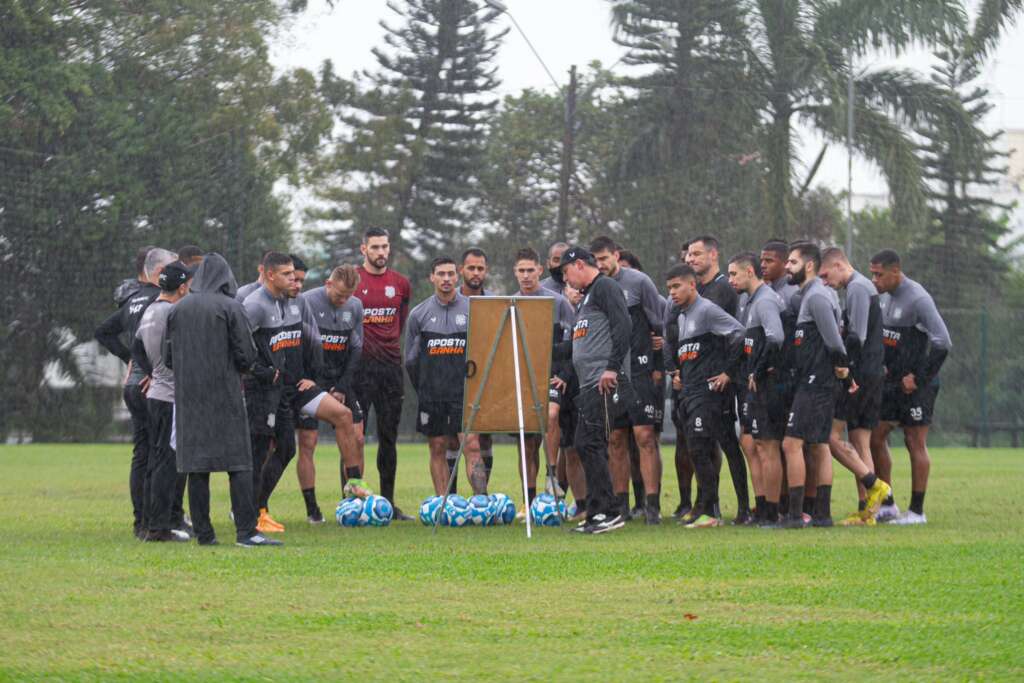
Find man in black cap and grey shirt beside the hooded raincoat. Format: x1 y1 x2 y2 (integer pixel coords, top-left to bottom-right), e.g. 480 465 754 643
132 261 191 543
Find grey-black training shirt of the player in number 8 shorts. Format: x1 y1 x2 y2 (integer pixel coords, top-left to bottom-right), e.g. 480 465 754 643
665 294 743 404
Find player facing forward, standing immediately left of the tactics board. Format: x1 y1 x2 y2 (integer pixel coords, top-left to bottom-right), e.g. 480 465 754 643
406 256 487 496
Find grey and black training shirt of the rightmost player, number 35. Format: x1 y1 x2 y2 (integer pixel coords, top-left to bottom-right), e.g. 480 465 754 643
879 276 952 386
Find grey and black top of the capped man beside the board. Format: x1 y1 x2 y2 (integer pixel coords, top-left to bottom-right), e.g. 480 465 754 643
571 273 632 390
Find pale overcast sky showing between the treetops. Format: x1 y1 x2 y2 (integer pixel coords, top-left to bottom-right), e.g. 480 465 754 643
272 0 1024 194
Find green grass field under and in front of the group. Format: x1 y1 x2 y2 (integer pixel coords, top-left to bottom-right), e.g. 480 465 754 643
0 444 1024 681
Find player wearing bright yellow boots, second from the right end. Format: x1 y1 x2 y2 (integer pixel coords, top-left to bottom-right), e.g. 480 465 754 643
818 247 892 526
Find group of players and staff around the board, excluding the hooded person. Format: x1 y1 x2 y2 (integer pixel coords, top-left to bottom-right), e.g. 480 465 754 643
97 228 950 545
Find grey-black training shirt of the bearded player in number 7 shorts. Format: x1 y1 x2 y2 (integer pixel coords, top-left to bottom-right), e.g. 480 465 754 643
794 278 849 389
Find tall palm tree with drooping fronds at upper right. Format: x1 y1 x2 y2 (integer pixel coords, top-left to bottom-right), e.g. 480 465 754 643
745 0 970 237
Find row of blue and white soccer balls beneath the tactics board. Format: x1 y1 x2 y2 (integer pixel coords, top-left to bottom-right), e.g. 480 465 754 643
420 494 565 526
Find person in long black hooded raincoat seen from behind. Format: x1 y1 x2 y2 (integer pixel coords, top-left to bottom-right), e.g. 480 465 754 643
164 254 283 548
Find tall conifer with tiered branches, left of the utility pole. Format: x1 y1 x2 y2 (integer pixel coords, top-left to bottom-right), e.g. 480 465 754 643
313 0 507 272
